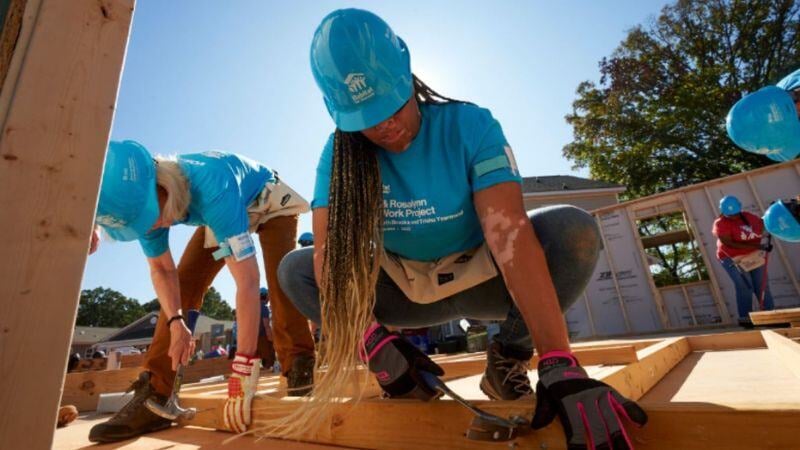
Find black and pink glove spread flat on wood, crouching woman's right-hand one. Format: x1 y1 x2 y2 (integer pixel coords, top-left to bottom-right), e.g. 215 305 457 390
531 351 647 450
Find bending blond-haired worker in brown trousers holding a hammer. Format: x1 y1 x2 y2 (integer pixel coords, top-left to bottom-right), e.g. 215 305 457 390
89 141 314 442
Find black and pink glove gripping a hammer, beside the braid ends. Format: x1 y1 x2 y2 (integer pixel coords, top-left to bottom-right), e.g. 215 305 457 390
362 322 444 401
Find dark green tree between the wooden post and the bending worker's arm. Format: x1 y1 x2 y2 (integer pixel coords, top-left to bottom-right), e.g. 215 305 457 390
76 287 145 328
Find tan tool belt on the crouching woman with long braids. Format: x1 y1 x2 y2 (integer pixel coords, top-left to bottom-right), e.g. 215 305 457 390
381 242 499 304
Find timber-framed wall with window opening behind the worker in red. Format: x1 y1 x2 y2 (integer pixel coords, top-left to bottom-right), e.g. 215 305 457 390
566 160 800 339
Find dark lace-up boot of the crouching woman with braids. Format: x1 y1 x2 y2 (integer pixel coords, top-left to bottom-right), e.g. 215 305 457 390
481 342 533 400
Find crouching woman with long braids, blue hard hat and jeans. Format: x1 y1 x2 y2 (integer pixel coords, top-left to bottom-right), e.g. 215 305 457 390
279 9 646 448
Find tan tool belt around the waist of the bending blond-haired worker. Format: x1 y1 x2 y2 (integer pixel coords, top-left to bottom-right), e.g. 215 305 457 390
203 172 311 248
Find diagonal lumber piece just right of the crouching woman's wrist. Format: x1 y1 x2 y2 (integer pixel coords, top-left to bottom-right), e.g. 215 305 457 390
600 337 691 400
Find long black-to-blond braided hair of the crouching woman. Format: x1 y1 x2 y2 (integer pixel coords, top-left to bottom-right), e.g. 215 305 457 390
260 76 457 438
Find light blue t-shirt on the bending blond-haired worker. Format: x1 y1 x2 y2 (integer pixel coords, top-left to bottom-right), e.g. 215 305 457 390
139 151 275 258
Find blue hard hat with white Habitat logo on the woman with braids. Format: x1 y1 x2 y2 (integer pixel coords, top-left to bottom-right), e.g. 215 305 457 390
311 9 413 131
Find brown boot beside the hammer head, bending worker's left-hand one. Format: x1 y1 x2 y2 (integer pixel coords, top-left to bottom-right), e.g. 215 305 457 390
89 372 172 442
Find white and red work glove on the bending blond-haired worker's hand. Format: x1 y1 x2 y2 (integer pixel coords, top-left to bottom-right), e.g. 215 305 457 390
222 353 261 433
